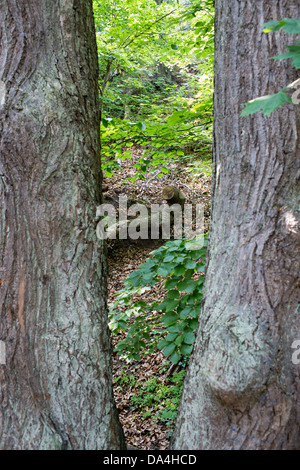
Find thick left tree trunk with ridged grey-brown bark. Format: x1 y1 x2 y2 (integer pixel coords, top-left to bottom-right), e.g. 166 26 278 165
0 0 124 450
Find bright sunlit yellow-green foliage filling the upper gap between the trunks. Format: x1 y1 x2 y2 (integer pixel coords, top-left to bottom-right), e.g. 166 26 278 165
93 0 214 179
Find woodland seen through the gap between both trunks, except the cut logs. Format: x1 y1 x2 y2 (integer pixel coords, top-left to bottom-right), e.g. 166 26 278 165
93 0 214 449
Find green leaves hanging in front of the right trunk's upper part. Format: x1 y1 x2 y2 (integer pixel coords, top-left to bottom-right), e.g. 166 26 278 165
241 18 300 116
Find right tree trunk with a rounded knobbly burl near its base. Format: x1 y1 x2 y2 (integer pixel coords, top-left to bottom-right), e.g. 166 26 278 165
171 0 300 450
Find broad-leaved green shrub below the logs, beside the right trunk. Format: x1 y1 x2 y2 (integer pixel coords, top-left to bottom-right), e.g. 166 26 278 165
109 235 207 364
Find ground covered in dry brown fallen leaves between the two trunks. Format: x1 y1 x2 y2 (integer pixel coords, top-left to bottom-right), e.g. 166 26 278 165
103 148 211 450
